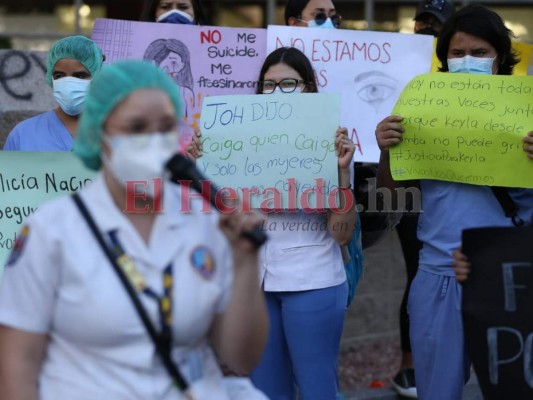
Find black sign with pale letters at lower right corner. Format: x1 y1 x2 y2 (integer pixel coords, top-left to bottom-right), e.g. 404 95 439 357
462 228 533 400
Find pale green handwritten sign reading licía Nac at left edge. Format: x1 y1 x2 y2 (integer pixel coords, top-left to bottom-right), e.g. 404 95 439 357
0 151 95 275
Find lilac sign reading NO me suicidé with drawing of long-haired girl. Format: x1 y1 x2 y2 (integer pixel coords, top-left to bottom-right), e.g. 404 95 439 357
92 19 266 145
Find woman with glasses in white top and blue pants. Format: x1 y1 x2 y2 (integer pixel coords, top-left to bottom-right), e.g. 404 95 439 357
247 48 356 400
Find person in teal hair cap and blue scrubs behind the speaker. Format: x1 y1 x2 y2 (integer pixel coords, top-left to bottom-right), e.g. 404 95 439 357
4 36 104 151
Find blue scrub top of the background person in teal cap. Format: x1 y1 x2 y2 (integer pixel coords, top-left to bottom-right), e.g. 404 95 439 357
4 110 74 151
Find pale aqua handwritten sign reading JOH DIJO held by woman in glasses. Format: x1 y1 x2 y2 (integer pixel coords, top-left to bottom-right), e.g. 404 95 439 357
197 93 340 209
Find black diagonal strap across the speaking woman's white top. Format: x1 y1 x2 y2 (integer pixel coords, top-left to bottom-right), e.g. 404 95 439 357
72 193 190 398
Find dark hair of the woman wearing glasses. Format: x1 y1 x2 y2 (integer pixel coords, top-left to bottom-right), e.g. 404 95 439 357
255 47 318 94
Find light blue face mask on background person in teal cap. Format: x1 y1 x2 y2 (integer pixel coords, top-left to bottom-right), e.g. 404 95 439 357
52 76 91 116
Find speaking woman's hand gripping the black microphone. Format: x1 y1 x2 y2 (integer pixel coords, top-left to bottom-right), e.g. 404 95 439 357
219 206 264 256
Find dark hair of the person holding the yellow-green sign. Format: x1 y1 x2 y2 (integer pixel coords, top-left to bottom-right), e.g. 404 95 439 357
437 4 520 75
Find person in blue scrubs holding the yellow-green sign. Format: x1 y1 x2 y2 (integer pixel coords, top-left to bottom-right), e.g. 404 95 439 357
376 4 533 400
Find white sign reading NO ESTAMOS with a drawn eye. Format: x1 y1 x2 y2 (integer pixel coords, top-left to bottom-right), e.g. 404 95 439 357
267 25 433 162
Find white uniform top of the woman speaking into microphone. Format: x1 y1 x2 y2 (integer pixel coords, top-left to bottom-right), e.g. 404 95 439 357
0 175 233 400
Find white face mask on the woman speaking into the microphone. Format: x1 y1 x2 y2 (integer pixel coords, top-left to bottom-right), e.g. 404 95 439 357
104 132 179 198
